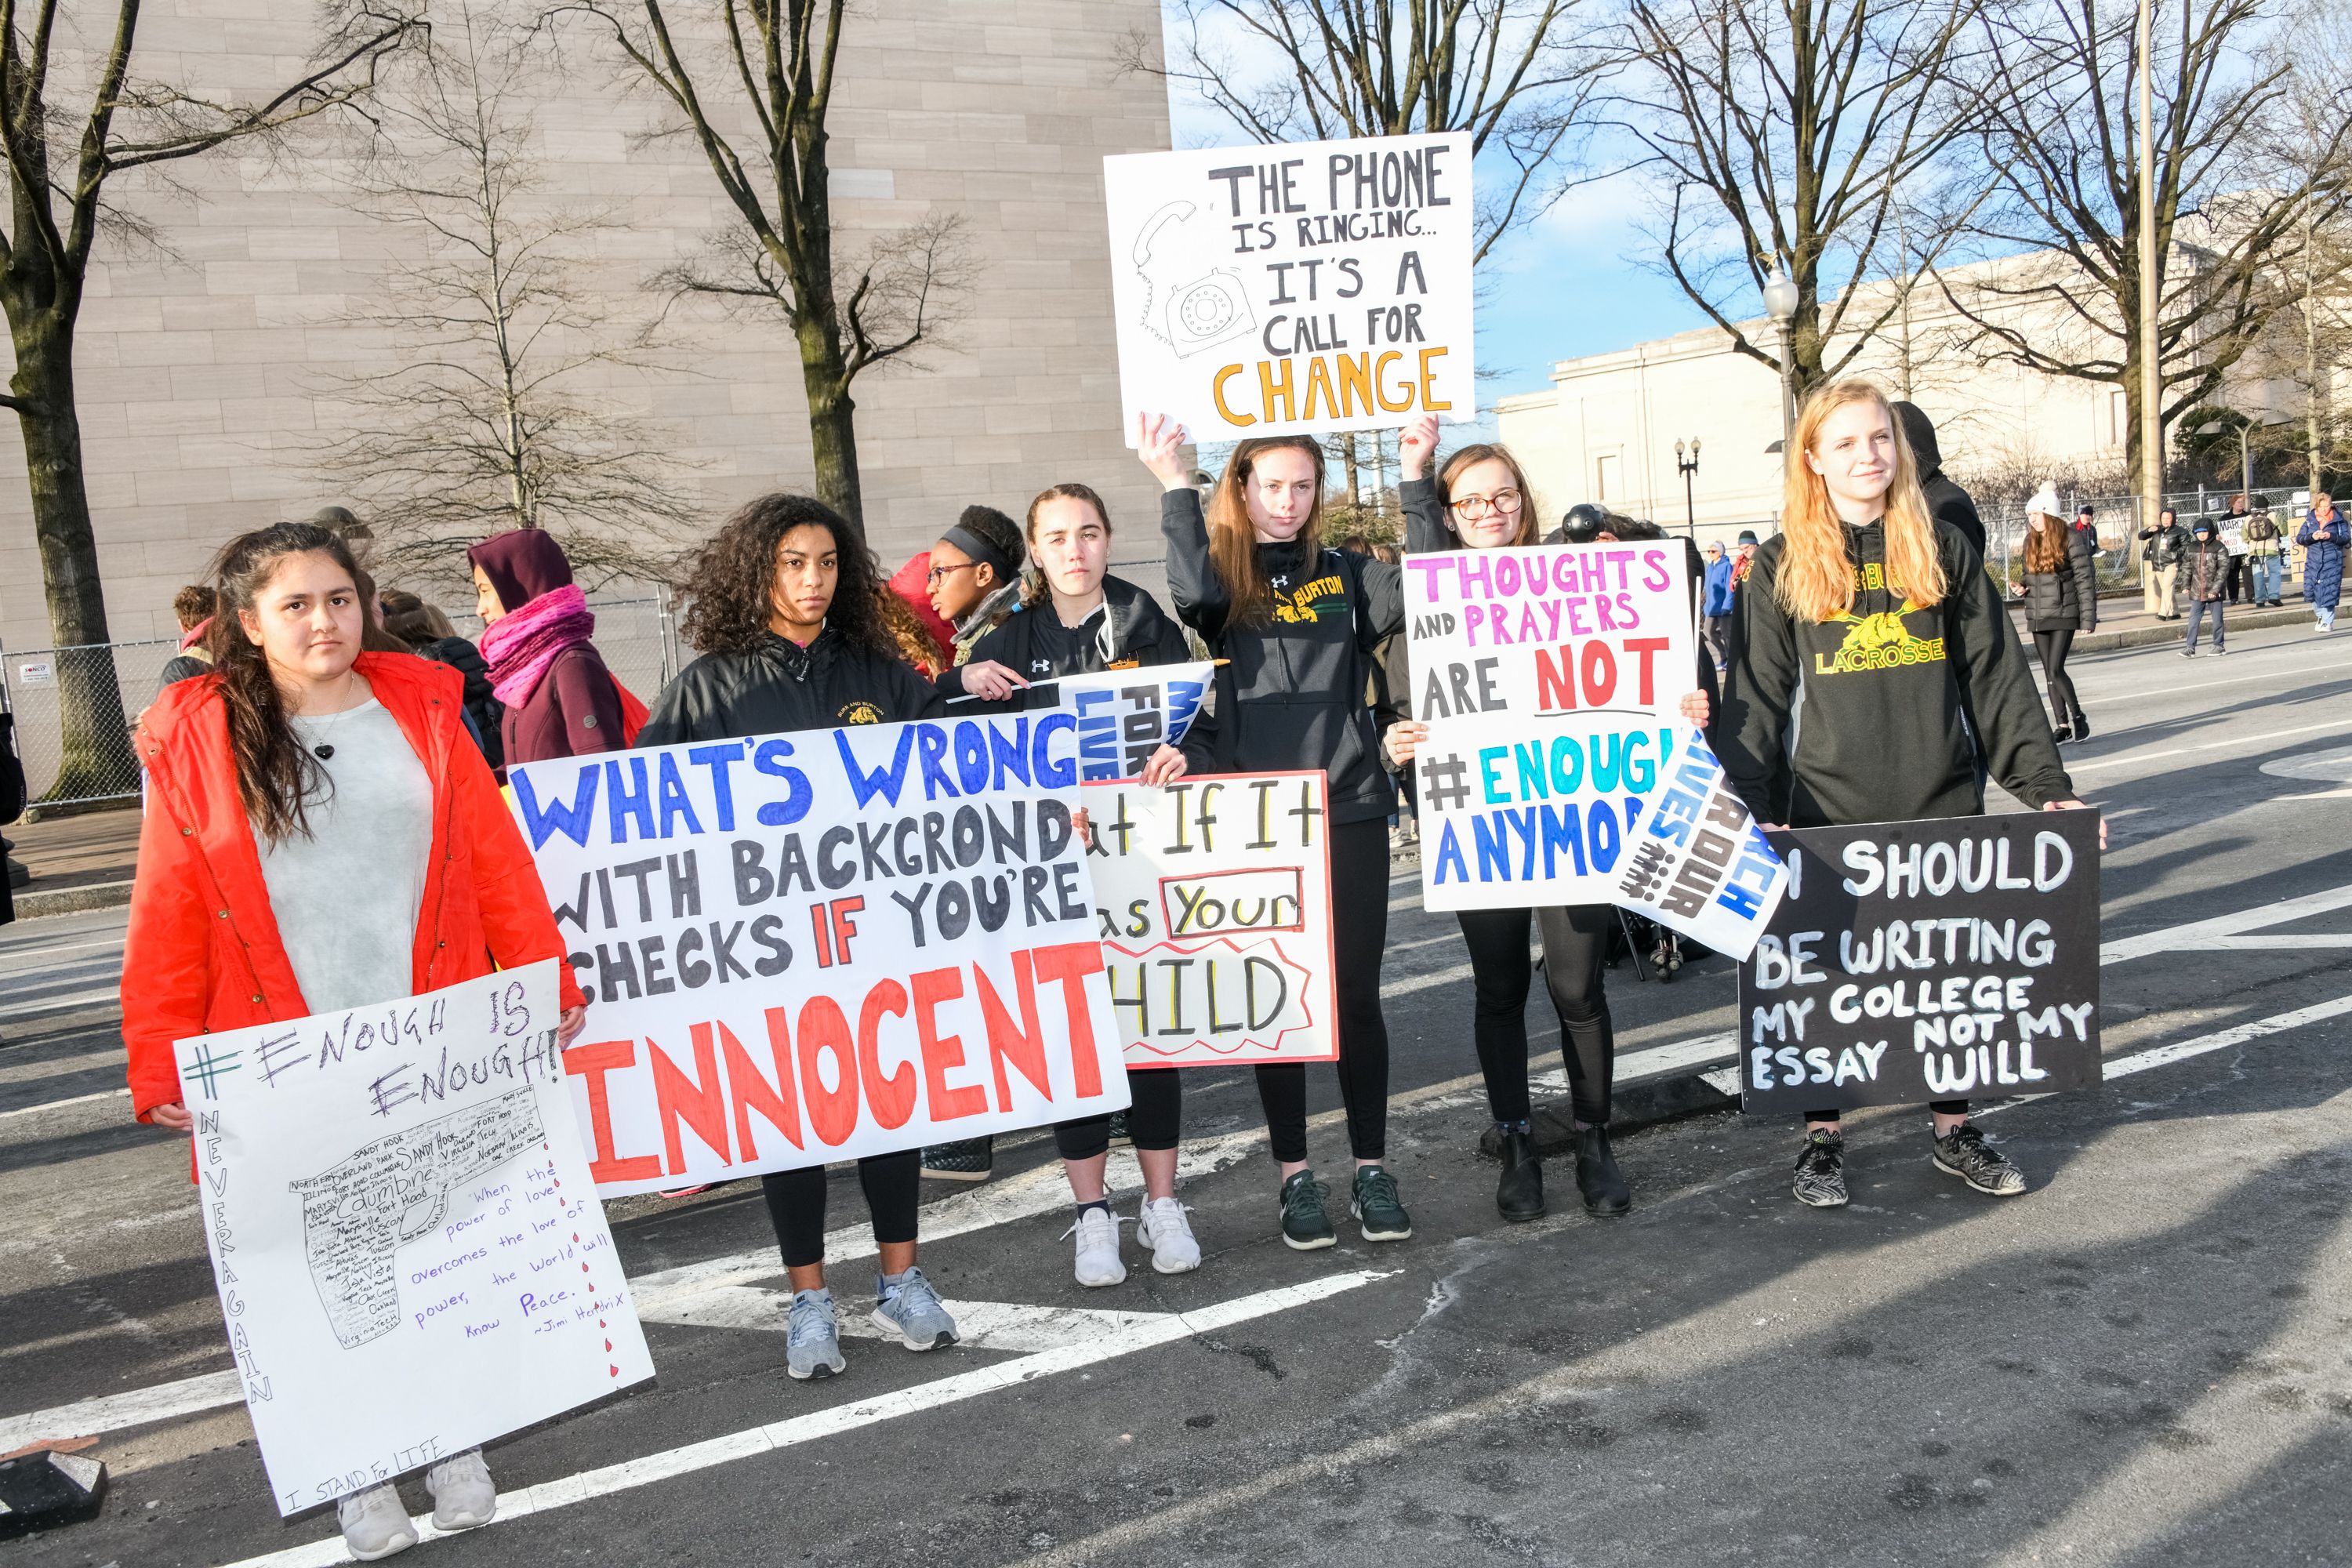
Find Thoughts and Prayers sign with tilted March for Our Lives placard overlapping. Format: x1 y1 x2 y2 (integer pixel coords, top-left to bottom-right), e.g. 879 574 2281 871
1404 541 1785 956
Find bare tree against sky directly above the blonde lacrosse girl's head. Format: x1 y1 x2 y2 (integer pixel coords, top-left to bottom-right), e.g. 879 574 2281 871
1616 0 1978 397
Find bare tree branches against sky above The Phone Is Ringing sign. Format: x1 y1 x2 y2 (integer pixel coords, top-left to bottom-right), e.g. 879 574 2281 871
1122 0 1599 261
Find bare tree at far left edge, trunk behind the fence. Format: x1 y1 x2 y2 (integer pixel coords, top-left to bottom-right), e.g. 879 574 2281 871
0 0 419 797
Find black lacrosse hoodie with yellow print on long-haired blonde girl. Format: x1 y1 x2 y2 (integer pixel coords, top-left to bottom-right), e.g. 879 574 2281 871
1712 522 2074 827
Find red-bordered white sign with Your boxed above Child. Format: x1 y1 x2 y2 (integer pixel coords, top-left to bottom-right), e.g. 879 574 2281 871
1084 774 1338 1067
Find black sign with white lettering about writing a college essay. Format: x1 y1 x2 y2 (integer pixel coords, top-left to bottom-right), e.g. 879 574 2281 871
1740 811 2100 1114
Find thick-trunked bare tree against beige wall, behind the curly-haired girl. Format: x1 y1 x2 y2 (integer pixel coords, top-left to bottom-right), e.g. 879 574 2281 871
550 0 969 532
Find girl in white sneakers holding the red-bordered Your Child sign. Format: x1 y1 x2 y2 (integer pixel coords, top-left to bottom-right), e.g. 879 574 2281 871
938 485 1200 1286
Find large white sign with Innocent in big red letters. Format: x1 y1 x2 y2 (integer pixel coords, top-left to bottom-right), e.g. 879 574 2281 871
510 710 1127 1196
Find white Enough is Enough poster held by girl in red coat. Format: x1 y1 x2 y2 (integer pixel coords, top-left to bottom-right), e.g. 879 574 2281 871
176 959 654 1514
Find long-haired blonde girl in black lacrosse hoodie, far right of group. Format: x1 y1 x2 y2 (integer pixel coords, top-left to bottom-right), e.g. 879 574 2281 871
1715 381 2105 1208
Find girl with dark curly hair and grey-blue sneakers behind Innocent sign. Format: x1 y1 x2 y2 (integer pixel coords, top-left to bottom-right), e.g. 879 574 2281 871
637 496 1002 1377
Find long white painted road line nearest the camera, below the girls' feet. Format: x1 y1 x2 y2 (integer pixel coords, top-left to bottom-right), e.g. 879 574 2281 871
212 1269 1385 1568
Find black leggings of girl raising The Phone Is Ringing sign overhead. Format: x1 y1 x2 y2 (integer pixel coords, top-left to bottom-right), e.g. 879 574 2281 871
1258 818 1388 1163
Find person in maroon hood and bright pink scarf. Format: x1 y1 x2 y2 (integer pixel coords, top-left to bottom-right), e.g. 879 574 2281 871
466 529 644 764
